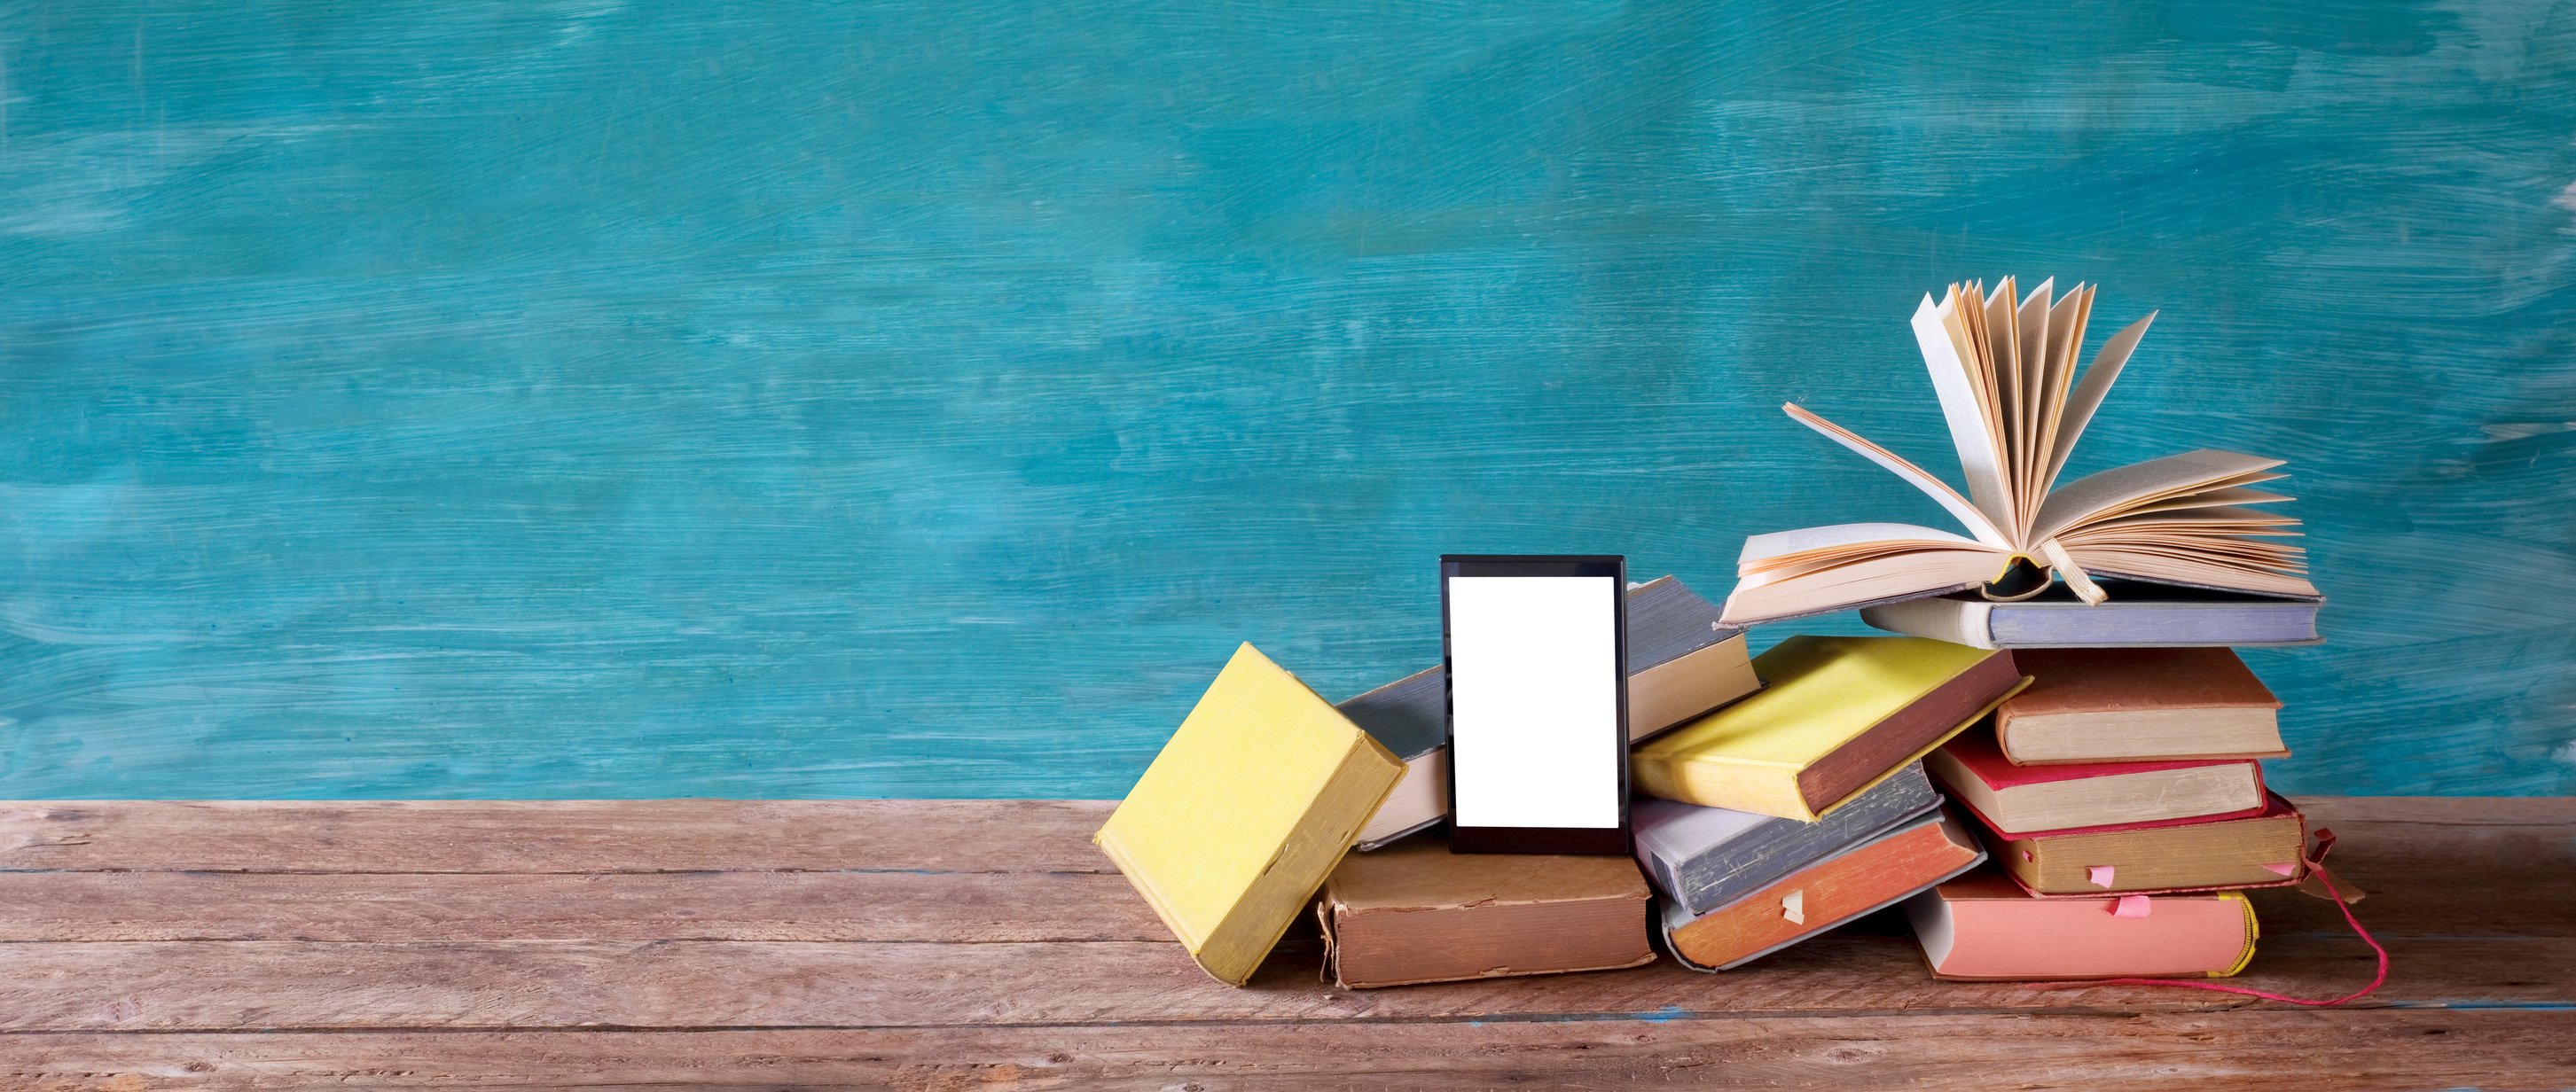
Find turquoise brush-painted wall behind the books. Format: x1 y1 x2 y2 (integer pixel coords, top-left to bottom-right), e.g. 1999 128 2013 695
0 0 2576 799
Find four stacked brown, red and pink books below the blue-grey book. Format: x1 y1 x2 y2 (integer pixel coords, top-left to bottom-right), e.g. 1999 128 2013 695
1907 634 2308 979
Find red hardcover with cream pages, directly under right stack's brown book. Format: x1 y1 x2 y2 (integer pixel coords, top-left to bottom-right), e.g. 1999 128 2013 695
1924 726 2267 837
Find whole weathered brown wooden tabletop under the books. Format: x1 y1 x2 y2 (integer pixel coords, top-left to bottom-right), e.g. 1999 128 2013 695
0 799 2576 1092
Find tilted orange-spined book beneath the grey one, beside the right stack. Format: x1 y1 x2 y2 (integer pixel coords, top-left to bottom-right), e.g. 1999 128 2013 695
1664 811 1986 971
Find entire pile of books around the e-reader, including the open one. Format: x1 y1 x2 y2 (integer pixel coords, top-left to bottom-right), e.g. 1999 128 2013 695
1095 281 2321 989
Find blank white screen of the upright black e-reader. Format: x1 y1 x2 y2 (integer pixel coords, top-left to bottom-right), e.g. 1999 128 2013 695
1448 577 1625 827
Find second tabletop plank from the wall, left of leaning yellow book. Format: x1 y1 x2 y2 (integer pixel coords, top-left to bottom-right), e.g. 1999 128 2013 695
0 873 1172 942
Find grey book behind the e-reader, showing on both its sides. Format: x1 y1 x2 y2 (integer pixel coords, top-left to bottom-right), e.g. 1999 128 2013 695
1335 577 1762 850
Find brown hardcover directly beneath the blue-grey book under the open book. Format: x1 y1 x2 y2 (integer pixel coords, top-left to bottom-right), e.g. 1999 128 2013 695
1993 649 2290 765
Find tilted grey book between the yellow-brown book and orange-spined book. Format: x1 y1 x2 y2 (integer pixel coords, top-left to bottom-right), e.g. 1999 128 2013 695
1631 762 1939 916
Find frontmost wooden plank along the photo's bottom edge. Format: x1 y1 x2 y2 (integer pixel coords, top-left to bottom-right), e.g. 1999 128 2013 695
0 1010 2576 1092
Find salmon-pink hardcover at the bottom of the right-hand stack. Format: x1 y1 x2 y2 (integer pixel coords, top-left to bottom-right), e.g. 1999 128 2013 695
1907 868 2259 981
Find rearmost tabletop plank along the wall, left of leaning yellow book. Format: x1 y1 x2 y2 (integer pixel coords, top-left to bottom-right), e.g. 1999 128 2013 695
0 801 1116 873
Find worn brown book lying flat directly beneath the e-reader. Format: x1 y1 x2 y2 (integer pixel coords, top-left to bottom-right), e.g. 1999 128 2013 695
1316 842 1654 989
